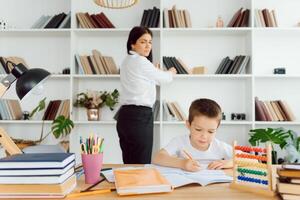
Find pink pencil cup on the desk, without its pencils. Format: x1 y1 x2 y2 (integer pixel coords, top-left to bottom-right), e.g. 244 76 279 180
81 153 103 184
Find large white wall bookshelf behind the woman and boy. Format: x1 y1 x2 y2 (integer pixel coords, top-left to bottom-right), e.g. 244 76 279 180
0 0 300 163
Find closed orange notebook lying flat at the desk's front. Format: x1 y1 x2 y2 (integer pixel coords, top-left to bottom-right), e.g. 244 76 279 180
113 168 173 195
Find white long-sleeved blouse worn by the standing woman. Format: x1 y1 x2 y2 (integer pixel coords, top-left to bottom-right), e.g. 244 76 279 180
120 51 172 107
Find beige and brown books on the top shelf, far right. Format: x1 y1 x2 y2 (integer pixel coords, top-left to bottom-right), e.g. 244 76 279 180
255 8 278 27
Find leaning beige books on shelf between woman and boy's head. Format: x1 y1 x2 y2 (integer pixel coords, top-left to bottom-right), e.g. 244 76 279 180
163 101 187 121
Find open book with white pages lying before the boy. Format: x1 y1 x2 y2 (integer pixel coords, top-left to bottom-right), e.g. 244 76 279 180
102 165 233 188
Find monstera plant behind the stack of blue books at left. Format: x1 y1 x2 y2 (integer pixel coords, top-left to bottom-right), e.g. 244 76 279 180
13 98 74 151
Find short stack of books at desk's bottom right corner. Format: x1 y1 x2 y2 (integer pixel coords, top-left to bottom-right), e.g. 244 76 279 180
277 164 300 200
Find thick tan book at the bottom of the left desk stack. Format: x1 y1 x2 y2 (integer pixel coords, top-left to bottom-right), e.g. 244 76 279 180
0 174 77 199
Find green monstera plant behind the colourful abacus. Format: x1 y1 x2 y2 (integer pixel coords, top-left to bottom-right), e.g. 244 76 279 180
248 128 300 164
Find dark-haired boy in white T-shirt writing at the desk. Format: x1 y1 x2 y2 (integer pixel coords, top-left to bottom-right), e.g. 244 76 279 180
153 99 232 172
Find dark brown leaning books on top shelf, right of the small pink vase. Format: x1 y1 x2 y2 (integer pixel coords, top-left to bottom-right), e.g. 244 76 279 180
227 8 250 27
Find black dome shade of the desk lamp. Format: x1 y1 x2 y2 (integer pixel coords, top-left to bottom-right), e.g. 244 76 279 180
16 68 50 99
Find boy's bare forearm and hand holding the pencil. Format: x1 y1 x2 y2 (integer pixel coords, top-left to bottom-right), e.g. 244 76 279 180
152 149 200 171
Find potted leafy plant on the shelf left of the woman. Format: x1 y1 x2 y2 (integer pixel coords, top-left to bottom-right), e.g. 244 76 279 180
74 89 119 121
